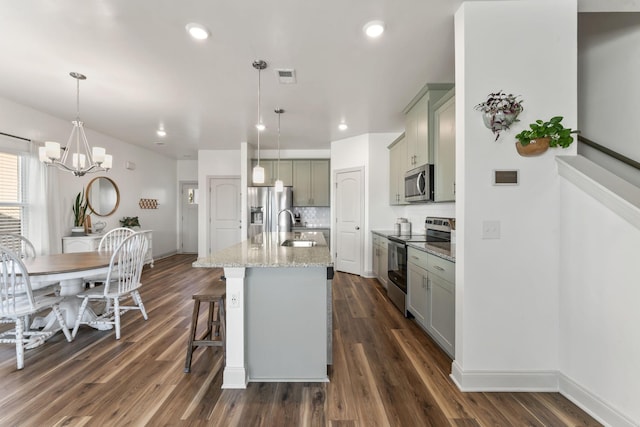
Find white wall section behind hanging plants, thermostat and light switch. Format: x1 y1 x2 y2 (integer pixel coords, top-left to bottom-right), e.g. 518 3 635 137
453 0 577 382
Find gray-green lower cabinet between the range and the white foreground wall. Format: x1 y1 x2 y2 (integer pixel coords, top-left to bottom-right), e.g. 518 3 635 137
407 247 456 357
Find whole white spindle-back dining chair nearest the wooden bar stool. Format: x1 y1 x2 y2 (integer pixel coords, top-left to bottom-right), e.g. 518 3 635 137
71 233 149 339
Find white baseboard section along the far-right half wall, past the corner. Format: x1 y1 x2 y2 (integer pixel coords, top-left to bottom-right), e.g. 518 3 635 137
558 373 640 427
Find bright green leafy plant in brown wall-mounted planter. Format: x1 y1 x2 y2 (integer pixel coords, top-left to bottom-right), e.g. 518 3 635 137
516 116 578 156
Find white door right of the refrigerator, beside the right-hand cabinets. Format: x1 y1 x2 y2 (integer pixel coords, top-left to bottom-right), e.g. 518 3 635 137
335 169 364 274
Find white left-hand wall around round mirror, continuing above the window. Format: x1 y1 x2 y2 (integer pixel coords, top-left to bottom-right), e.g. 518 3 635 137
0 99 177 257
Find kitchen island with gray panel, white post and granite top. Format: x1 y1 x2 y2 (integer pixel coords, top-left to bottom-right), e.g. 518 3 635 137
193 232 333 388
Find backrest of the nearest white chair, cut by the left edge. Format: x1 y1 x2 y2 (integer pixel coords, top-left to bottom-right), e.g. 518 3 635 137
0 246 35 317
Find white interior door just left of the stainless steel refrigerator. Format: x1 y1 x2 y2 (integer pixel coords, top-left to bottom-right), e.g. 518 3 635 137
209 178 242 254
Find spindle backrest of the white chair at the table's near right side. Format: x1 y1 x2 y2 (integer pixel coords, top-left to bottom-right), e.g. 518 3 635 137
104 233 149 295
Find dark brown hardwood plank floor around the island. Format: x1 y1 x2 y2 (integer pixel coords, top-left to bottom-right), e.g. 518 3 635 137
0 255 599 427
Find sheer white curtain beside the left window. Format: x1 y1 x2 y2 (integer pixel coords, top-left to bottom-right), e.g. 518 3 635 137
25 143 62 255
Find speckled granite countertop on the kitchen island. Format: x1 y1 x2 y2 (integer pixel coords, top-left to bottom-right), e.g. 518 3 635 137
193 231 333 268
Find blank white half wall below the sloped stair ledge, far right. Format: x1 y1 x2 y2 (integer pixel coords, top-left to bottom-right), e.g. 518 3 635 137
559 180 640 425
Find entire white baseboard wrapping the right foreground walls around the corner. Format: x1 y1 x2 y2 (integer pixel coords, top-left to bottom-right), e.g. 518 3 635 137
451 361 640 427
